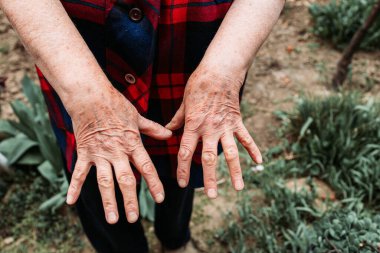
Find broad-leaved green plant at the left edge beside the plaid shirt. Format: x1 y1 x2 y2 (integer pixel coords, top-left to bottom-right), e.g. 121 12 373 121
0 77 68 210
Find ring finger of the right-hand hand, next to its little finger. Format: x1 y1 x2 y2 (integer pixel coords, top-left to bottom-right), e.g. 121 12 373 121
221 133 244 191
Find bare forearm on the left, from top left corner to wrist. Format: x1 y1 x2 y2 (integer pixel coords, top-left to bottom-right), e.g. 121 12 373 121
0 0 110 113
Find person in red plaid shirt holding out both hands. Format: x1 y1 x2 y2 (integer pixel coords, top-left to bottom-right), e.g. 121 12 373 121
0 0 284 252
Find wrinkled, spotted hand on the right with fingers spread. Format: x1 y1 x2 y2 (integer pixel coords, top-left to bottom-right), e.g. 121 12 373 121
166 69 262 198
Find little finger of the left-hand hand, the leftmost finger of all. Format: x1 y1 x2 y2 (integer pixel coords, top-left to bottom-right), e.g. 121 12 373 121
66 156 91 205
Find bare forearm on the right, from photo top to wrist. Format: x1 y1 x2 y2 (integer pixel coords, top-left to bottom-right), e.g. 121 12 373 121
201 0 285 78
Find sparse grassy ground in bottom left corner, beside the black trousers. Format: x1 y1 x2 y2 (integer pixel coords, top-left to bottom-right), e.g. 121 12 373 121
0 168 84 252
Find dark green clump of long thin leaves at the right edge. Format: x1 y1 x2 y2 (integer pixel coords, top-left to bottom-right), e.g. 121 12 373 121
288 93 380 208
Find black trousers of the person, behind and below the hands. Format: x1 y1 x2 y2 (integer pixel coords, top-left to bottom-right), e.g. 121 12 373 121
71 168 194 253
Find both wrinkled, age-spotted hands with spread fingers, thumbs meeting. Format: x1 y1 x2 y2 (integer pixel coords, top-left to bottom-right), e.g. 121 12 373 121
67 66 262 224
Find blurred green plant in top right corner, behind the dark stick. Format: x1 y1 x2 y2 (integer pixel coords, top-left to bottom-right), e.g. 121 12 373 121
309 0 380 49
